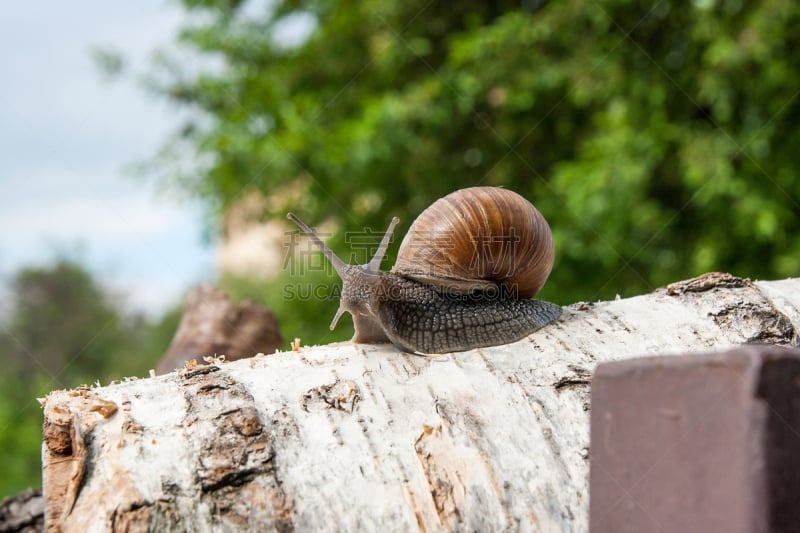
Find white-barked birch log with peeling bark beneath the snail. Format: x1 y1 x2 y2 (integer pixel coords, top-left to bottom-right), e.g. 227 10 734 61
43 273 800 532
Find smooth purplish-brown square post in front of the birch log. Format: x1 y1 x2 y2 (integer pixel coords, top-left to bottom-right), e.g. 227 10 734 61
590 345 800 533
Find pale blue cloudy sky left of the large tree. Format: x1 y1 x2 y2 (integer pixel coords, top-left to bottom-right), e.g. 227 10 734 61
0 0 214 316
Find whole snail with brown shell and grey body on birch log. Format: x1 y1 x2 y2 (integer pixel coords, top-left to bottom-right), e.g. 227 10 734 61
287 187 561 354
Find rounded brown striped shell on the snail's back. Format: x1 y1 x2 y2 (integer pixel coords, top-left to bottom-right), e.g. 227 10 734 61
392 187 555 298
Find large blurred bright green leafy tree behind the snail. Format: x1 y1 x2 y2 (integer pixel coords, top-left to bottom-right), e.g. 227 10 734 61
157 0 800 324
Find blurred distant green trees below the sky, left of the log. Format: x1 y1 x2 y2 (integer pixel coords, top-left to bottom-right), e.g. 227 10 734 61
0 259 180 498
